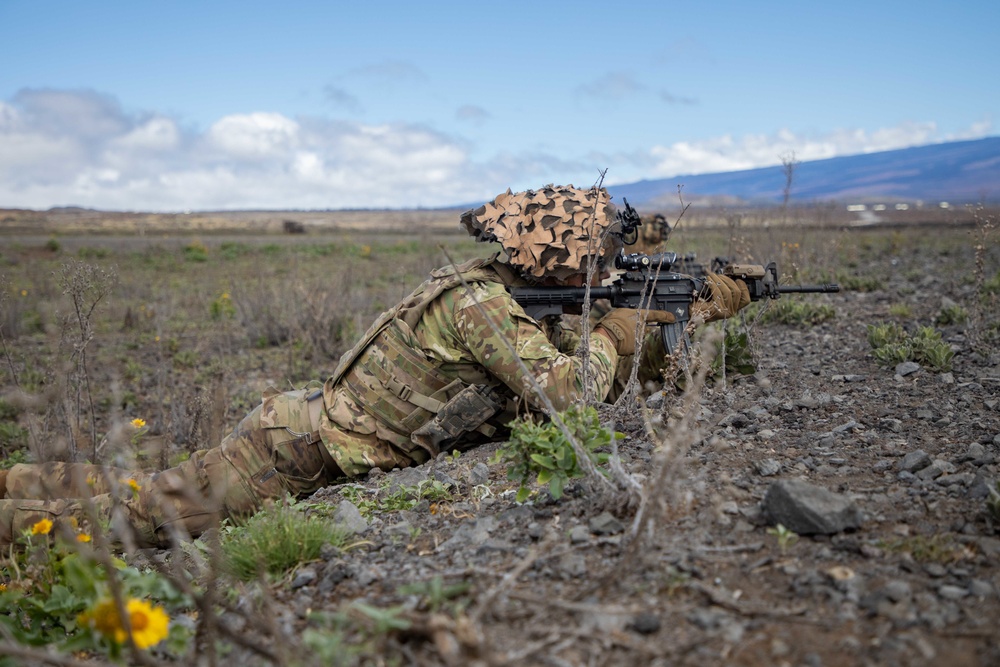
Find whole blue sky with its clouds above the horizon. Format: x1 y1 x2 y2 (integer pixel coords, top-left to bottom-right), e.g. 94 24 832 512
0 0 1000 210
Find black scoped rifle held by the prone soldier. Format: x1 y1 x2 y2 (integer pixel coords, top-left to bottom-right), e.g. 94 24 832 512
508 252 840 354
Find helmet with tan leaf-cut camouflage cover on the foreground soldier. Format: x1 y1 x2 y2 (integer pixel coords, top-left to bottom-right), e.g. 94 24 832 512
462 185 621 279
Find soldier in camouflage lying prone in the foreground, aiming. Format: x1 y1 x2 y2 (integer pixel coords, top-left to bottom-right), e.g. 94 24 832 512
0 185 750 546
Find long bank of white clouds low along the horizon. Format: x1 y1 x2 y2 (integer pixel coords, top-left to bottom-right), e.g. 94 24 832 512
0 90 992 211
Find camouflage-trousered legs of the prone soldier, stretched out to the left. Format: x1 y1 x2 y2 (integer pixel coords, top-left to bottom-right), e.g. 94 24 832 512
0 391 335 546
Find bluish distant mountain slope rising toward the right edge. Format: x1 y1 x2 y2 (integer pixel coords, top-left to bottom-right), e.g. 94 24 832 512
607 137 1000 208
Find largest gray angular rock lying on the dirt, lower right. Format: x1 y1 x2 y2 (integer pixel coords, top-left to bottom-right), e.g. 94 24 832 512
762 479 862 535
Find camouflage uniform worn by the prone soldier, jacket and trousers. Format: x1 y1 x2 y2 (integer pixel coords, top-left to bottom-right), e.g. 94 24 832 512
0 256 618 546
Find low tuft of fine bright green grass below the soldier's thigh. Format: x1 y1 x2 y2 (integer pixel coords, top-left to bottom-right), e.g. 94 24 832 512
221 501 347 581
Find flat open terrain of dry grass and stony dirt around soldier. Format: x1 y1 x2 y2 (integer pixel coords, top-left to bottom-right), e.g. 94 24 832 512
0 211 1000 666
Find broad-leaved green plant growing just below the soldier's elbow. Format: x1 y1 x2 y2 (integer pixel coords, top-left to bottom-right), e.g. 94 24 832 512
495 406 612 502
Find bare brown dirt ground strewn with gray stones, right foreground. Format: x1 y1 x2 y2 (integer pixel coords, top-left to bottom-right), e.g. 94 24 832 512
252 237 1000 666
